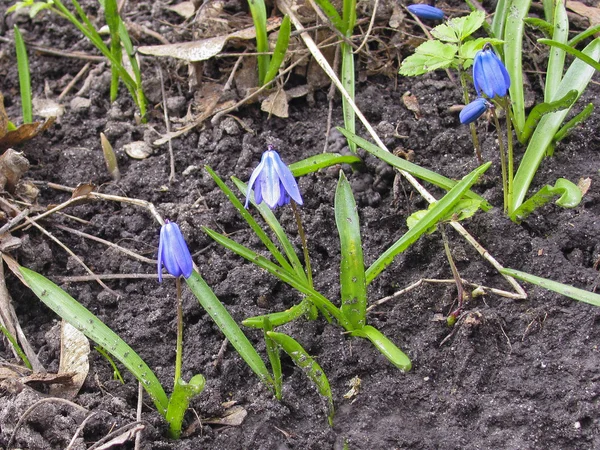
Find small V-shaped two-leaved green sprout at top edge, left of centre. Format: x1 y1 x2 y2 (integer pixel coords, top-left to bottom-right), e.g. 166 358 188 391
248 0 292 86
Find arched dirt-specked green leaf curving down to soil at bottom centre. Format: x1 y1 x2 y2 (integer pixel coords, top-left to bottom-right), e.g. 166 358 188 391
267 331 334 426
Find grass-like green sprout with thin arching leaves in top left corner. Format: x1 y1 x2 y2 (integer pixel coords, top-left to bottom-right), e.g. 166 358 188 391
7 0 146 120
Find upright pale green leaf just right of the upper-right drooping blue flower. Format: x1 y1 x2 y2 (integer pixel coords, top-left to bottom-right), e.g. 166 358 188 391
504 0 531 134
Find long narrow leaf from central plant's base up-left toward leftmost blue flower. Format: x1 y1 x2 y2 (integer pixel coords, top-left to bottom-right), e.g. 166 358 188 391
202 227 352 331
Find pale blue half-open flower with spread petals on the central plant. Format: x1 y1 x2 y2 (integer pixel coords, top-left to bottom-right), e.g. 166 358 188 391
245 145 302 209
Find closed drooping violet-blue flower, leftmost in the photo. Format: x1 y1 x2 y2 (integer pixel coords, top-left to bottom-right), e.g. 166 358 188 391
158 220 193 282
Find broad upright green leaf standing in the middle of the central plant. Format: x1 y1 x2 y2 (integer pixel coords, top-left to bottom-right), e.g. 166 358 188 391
335 170 367 329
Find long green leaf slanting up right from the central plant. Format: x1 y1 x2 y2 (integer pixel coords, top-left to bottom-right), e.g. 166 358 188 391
366 162 491 285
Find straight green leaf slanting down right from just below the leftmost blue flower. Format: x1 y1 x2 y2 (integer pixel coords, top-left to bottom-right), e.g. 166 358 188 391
185 271 273 387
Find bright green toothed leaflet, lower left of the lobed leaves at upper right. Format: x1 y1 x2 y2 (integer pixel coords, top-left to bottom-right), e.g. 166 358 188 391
400 41 458 77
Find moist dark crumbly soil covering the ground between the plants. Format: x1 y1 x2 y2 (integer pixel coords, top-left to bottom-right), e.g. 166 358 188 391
0 0 600 449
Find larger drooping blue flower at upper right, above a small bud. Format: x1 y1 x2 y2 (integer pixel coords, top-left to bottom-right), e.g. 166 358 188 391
473 44 510 98
